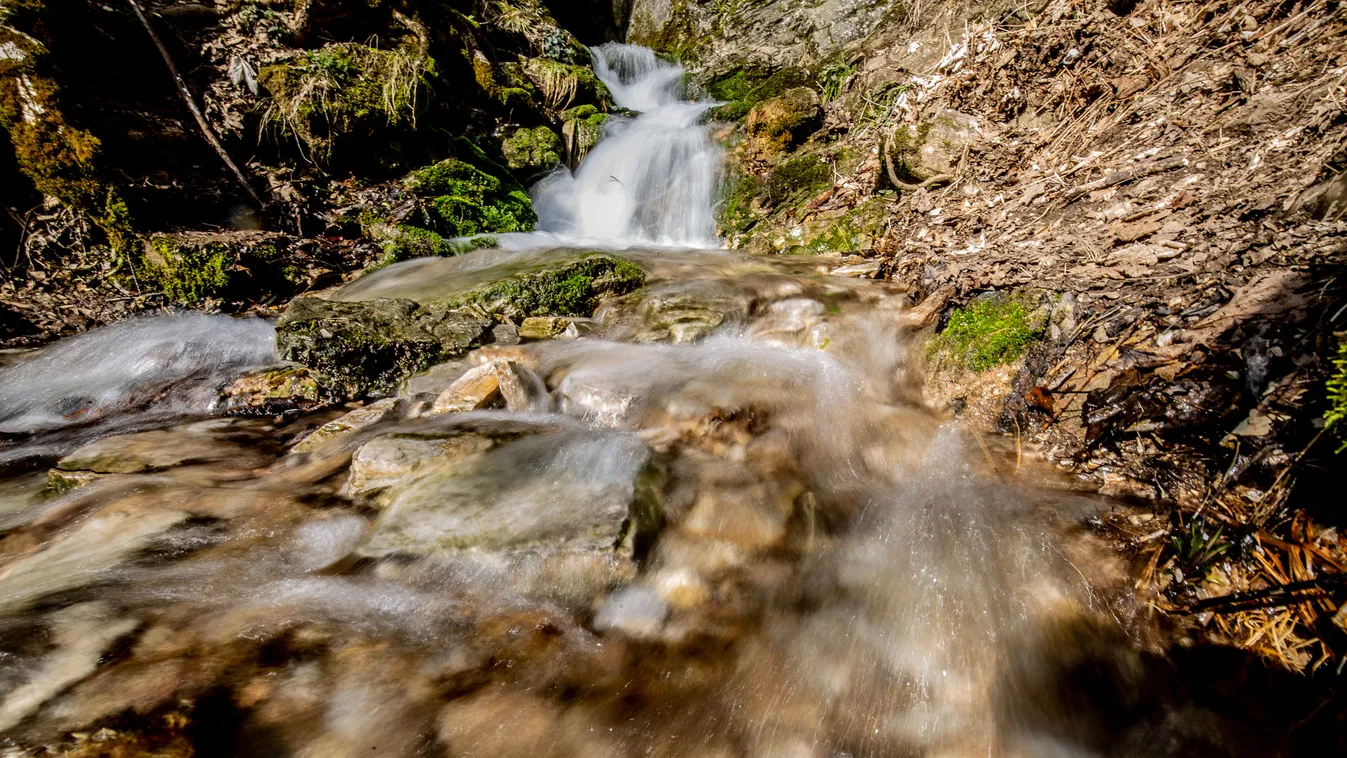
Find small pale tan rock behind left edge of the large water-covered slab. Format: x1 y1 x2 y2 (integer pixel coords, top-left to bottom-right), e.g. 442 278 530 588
342 432 494 495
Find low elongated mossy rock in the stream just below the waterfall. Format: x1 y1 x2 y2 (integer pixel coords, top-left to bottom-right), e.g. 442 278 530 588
459 256 645 320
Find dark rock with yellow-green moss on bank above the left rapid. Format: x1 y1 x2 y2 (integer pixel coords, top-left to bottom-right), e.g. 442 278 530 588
137 232 303 306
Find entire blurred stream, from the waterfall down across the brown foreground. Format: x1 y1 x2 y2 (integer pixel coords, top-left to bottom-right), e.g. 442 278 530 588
0 46 1309 758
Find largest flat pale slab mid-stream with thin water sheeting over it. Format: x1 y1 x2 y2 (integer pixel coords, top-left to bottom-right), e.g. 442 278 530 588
358 428 663 596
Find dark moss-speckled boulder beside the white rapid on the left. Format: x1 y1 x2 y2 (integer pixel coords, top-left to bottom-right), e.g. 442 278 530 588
276 298 492 397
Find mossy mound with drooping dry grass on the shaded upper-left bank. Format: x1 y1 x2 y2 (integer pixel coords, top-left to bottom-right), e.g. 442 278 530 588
257 42 435 163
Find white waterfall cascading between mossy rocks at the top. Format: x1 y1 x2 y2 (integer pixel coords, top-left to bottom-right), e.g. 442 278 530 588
532 43 721 248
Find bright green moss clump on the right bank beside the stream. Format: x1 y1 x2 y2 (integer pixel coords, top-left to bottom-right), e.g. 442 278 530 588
929 294 1045 372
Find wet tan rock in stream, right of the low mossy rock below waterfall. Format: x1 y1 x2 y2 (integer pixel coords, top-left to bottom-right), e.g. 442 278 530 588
637 280 754 343
